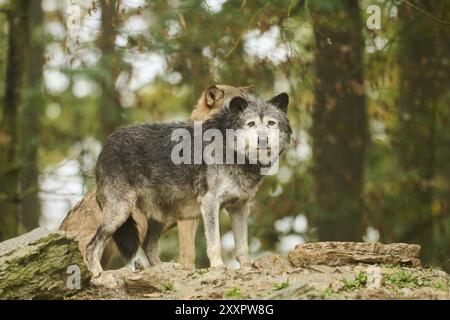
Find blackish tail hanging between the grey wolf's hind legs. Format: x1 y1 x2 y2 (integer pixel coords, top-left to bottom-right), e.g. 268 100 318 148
113 217 140 261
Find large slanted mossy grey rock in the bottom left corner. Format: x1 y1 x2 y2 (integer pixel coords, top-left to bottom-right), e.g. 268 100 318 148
0 228 91 299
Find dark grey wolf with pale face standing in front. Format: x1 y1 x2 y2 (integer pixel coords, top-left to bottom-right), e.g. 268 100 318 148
87 93 291 276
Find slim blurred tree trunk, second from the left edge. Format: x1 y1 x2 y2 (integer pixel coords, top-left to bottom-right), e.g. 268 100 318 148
20 1 44 231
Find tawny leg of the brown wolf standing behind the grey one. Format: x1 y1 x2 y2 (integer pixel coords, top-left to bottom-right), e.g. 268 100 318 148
177 219 198 268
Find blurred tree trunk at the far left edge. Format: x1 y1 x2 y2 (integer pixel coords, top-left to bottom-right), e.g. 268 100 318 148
0 0 30 241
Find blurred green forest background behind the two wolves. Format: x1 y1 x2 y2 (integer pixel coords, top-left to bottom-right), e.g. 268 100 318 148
0 0 450 270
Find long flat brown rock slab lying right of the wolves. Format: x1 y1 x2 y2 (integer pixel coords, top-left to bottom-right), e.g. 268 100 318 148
288 242 421 267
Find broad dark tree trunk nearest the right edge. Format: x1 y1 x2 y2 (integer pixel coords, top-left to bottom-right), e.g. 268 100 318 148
397 0 450 262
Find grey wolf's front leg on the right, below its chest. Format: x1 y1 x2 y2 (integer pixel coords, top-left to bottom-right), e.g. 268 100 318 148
229 204 250 268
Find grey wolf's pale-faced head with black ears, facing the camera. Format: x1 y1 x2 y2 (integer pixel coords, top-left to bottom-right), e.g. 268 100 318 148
227 93 292 172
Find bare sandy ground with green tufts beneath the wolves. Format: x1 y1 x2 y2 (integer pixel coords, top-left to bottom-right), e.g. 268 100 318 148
71 254 450 299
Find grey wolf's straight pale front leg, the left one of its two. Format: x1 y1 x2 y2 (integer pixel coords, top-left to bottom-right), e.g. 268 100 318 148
201 193 223 268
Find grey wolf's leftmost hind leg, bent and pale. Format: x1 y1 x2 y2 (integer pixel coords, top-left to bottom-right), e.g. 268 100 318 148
87 200 134 277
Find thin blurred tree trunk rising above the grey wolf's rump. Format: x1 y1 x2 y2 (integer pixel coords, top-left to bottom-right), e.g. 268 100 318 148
98 0 123 142
